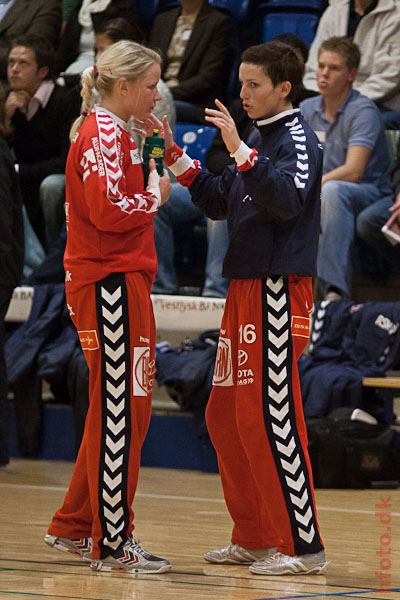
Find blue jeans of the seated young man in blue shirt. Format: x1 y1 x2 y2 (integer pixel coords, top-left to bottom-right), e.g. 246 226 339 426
317 180 390 298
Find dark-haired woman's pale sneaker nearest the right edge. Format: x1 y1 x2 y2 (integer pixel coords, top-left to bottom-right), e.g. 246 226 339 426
249 550 329 575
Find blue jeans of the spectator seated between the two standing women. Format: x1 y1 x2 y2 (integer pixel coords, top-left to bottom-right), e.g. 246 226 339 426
153 183 229 297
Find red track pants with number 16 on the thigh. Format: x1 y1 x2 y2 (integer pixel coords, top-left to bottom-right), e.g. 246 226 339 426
206 275 323 555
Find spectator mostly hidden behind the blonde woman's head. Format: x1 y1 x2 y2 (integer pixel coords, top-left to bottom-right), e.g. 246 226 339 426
96 17 176 139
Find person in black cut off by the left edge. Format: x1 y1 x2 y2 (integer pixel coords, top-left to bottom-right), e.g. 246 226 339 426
0 79 24 466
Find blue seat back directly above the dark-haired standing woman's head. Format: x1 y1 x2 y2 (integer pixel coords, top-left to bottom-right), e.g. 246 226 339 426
262 12 319 46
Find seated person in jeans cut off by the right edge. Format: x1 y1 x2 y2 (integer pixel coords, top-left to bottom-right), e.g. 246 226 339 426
356 134 400 274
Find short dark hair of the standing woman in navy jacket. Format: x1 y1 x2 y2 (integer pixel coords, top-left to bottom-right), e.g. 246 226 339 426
240 41 303 101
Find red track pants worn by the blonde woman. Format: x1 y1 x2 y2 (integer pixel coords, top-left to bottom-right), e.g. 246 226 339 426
49 273 155 558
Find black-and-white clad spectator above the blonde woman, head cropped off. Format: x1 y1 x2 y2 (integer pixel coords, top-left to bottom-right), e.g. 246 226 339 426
56 0 138 76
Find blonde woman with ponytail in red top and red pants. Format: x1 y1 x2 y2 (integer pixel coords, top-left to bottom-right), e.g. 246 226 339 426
45 41 171 573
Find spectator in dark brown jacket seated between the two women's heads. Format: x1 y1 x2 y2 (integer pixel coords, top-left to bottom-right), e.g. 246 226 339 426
150 0 234 124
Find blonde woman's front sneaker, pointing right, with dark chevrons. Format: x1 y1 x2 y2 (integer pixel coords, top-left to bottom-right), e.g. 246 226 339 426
90 537 171 573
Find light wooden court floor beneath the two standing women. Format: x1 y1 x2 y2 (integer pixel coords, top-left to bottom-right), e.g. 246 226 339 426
0 459 400 600
